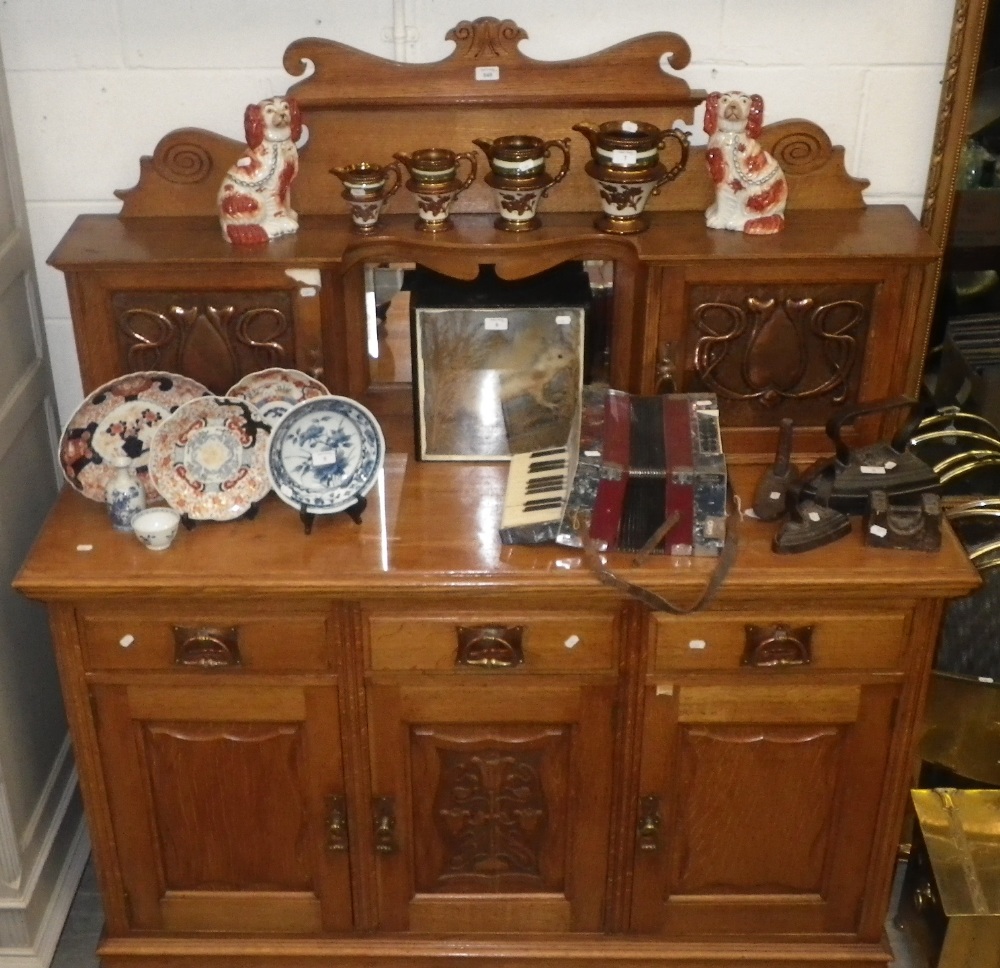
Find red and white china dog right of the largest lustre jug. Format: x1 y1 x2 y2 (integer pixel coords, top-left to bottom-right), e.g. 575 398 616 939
705 91 788 235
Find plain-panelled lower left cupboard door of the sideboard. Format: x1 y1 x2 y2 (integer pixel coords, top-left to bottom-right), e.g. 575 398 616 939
93 683 352 933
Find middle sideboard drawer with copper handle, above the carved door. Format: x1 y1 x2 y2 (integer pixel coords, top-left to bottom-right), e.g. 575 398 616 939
368 612 615 672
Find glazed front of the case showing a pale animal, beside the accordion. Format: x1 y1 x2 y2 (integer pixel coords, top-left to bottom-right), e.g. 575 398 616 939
412 305 585 461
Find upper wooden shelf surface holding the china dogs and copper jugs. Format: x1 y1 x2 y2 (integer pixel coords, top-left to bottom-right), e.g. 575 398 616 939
49 205 937 271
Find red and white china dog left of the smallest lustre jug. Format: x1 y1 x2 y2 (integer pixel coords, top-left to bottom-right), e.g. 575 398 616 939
217 97 302 245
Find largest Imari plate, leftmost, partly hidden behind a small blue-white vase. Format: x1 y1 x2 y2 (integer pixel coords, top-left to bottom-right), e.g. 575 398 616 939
59 370 210 502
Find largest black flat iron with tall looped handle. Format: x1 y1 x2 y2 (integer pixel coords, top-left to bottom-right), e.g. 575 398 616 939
803 397 941 514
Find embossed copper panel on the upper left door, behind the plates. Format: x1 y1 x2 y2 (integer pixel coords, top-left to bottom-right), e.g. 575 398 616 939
113 290 295 394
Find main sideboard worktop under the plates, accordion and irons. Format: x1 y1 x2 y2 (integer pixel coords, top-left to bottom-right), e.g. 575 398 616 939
15 450 978 607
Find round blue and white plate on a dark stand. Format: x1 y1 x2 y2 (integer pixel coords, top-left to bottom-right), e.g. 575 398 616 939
267 396 385 514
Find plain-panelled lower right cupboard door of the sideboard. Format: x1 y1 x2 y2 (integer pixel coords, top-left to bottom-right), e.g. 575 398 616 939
631 679 897 935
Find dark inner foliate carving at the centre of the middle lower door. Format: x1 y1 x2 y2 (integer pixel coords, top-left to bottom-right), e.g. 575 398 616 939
434 749 549 879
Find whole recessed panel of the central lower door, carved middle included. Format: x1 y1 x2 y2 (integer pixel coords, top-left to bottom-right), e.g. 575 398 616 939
413 726 570 893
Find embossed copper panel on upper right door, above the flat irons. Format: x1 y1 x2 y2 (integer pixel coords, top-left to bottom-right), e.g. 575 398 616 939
688 283 876 426
